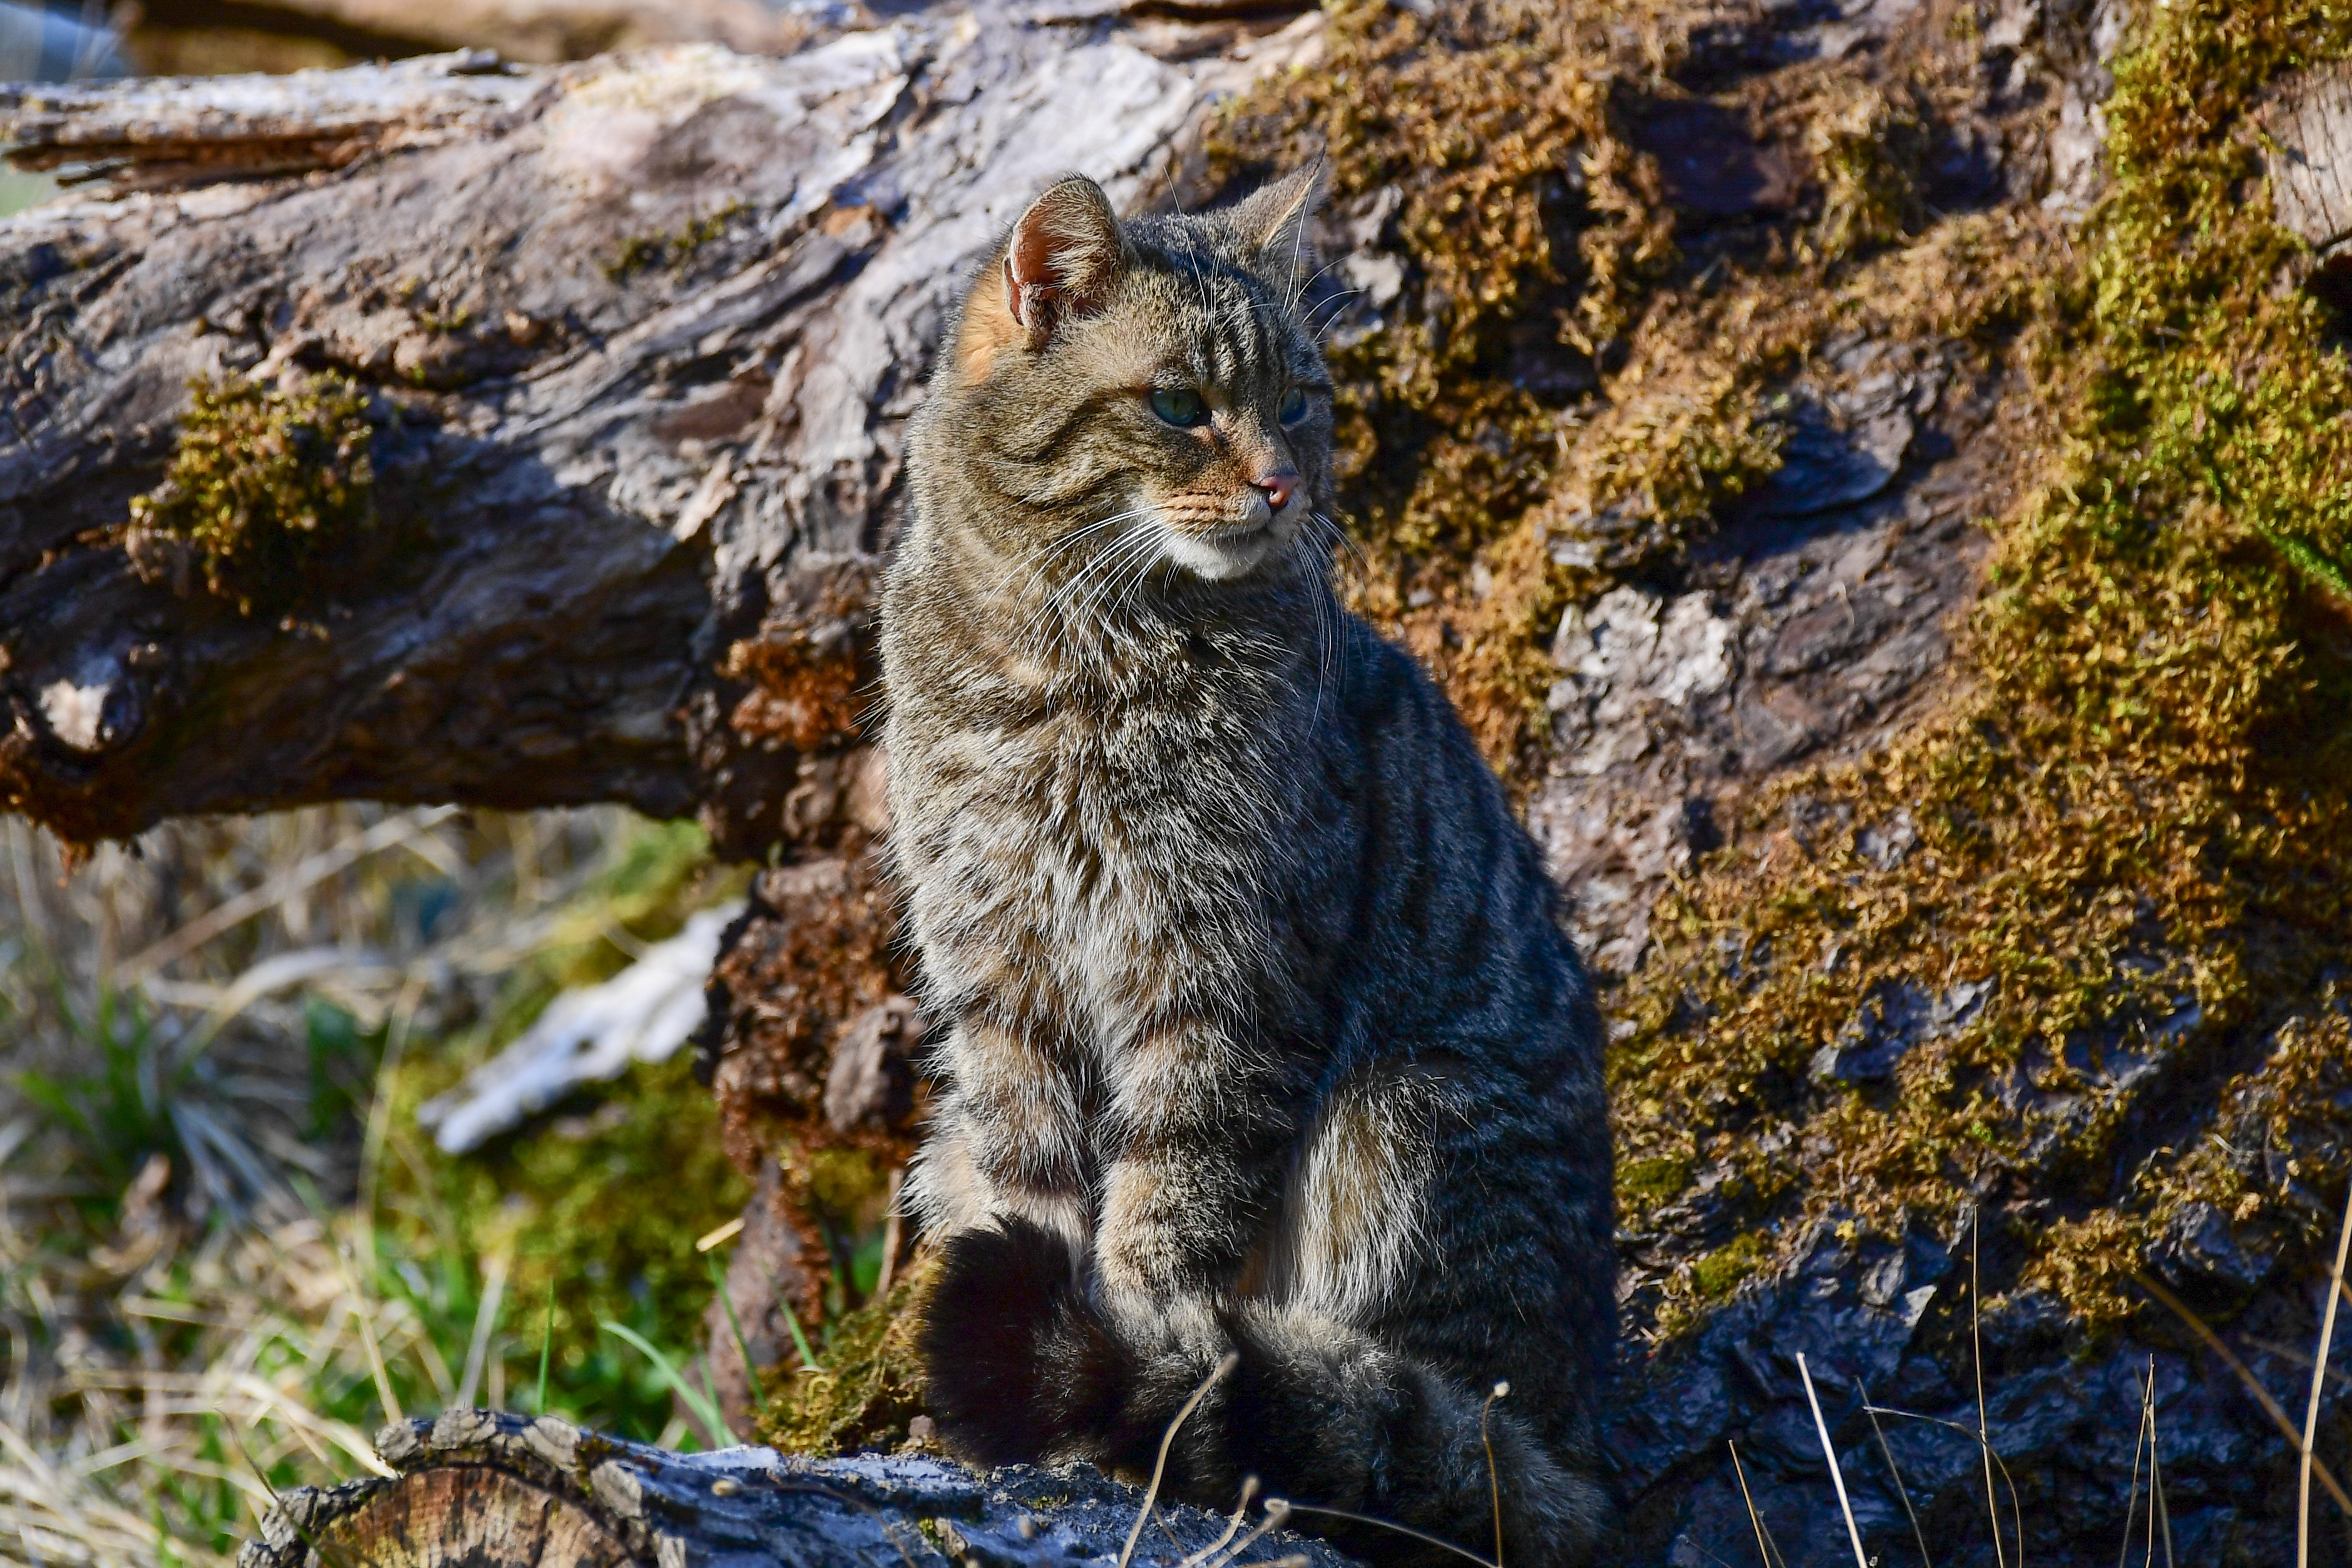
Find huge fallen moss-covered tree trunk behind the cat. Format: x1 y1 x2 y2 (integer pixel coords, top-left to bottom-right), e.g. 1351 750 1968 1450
14 0 2352 1563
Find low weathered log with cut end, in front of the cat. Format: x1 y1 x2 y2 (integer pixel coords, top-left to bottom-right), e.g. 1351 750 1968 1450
237 1410 1348 1568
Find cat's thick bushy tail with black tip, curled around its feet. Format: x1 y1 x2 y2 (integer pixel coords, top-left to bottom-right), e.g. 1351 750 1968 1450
925 1220 1613 1568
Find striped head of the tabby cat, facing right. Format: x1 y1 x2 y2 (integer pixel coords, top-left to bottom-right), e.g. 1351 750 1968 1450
925 174 1331 583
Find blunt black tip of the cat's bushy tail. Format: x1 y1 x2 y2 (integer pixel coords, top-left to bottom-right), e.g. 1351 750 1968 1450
922 1217 1134 1465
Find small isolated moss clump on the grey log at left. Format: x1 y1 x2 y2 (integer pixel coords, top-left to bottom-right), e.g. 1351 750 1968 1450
127 376 376 616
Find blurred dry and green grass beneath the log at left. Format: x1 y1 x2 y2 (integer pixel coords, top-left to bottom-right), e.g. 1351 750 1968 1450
0 806 741 1565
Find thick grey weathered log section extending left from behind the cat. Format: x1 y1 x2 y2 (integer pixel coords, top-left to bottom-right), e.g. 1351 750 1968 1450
0 7 1320 849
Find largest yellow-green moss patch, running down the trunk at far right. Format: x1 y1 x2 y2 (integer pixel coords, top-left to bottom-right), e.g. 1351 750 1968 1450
1611 3 2352 1326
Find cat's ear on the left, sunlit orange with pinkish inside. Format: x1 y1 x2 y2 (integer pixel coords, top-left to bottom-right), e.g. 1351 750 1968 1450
955 174 1134 386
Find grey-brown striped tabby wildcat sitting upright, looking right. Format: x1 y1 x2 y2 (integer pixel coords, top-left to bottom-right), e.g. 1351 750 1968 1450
882 177 1616 1568
